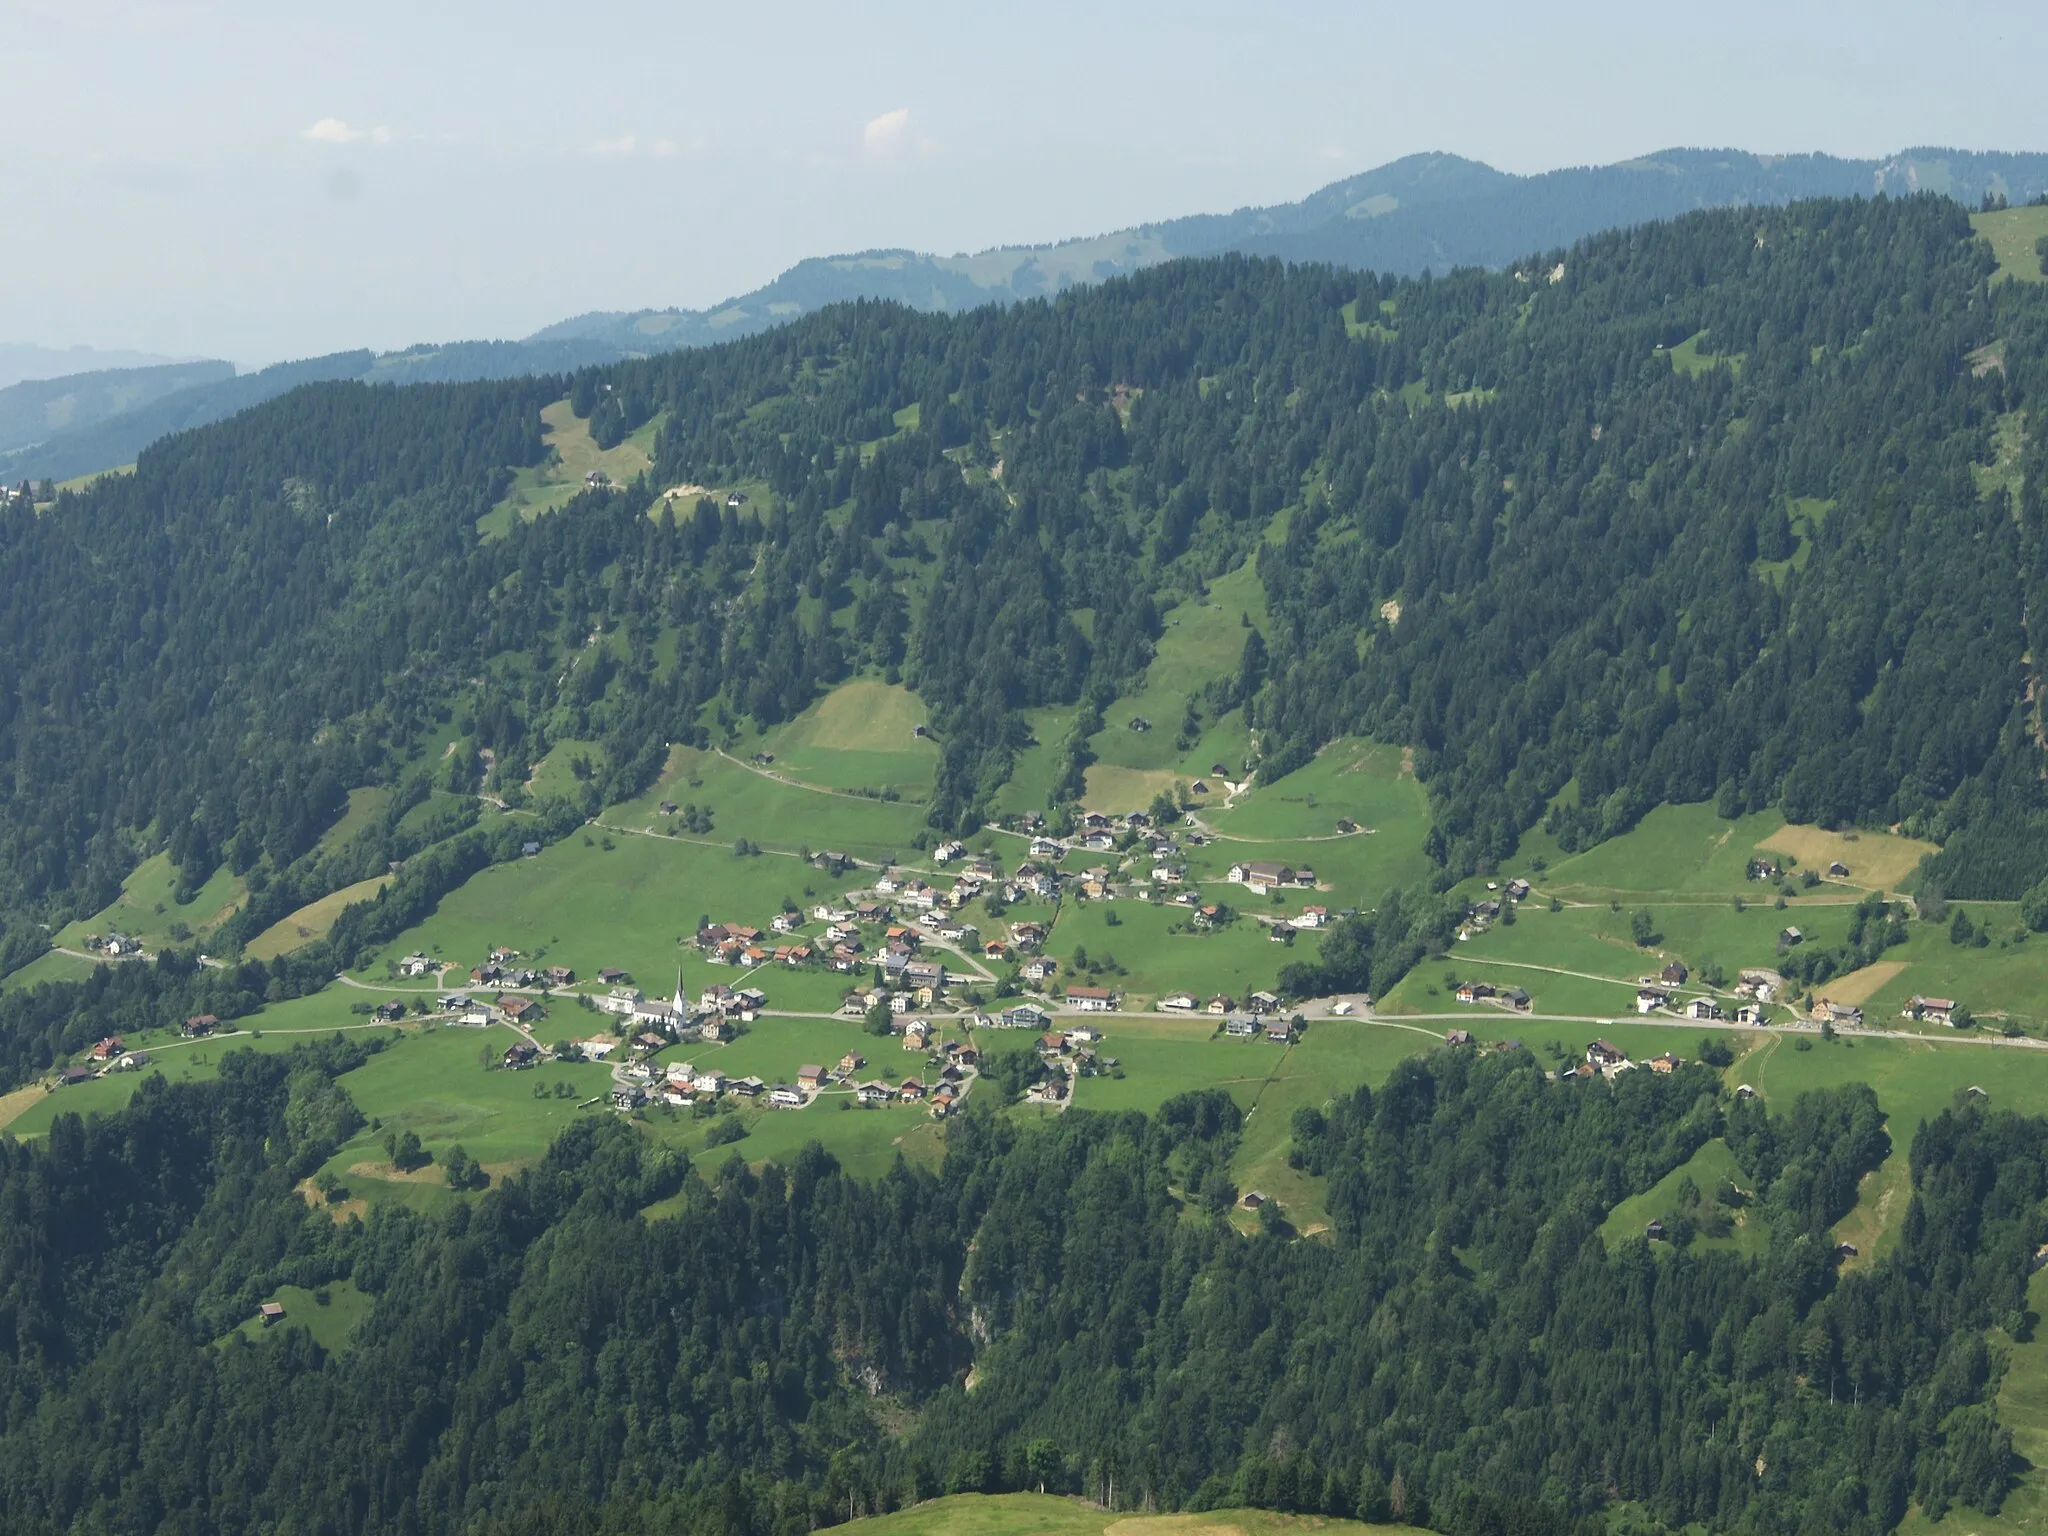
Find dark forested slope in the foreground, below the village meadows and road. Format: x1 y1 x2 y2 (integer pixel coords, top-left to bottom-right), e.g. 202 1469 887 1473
0 1040 2048 1532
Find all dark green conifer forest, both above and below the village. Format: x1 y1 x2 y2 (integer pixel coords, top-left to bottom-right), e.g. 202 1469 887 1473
0 199 2048 1536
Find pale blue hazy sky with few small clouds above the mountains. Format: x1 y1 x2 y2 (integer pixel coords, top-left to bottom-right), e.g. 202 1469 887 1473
0 0 2048 362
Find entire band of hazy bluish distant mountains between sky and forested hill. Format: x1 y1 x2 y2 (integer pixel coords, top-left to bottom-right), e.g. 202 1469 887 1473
0 150 2048 481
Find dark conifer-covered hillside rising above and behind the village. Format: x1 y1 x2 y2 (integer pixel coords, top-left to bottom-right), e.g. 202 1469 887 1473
0 199 2048 987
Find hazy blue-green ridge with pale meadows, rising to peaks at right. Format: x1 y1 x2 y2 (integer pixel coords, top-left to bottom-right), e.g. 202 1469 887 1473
528 147 2048 352
